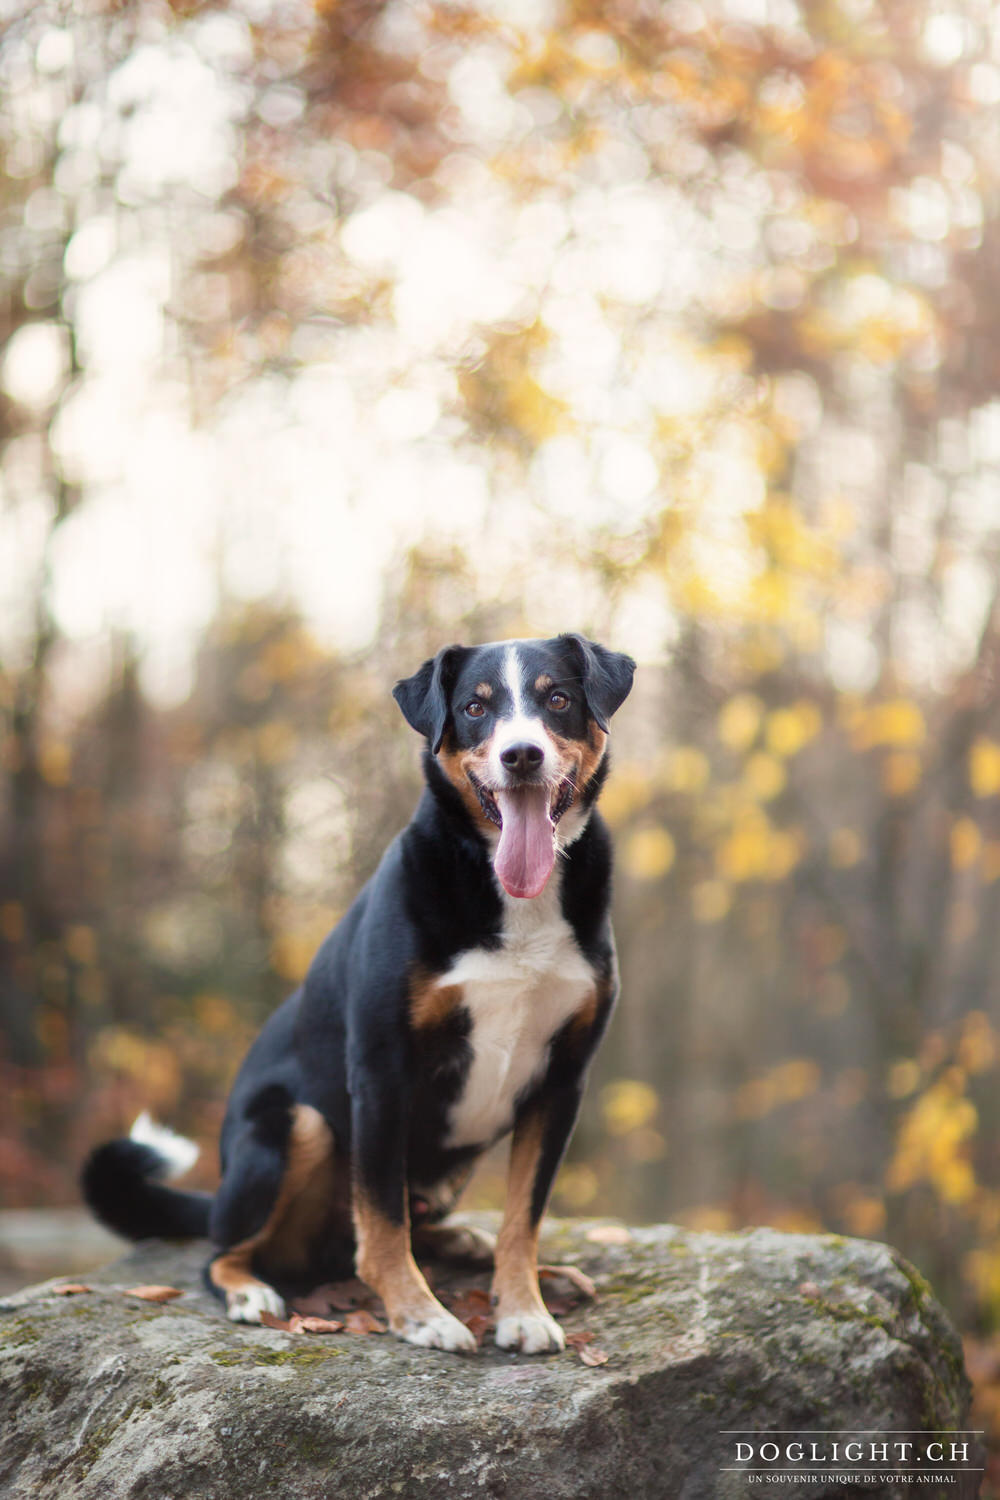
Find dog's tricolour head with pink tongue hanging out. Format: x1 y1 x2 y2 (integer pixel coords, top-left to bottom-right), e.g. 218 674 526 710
393 635 636 897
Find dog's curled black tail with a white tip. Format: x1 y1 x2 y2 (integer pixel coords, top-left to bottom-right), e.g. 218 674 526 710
81 1112 211 1239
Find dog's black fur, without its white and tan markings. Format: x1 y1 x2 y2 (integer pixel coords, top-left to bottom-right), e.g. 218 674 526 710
84 635 634 1326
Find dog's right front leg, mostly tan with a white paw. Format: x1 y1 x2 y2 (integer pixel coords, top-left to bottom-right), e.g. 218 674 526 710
493 1085 580 1355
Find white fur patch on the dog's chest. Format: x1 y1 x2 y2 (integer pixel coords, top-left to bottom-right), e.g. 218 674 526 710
438 876 594 1146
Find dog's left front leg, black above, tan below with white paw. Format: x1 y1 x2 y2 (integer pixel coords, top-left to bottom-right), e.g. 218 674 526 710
351 1077 475 1355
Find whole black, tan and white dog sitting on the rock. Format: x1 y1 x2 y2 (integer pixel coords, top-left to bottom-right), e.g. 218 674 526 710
84 635 634 1355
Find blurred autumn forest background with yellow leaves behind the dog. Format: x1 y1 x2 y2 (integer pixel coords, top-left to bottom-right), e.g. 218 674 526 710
0 0 1000 1418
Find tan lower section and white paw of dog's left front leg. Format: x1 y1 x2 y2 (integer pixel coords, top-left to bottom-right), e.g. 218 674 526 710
354 1187 475 1353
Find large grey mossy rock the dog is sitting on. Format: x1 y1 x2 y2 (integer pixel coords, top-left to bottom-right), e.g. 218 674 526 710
0 1217 982 1500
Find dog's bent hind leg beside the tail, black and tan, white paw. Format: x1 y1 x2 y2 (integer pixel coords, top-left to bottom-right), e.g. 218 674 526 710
208 1091 333 1323
